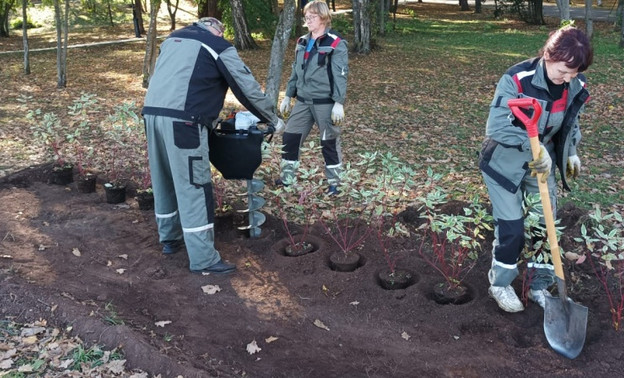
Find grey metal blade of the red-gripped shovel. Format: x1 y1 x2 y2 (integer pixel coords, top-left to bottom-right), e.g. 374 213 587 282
544 296 588 359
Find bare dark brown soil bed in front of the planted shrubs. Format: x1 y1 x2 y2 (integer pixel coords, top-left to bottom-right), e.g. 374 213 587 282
0 169 624 377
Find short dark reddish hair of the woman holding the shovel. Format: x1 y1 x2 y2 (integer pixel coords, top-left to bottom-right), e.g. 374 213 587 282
540 25 594 72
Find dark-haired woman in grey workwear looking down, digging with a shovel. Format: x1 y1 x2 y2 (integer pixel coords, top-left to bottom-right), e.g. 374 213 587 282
479 26 593 312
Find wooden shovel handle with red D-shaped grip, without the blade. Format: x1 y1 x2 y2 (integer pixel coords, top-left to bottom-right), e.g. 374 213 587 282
507 98 565 281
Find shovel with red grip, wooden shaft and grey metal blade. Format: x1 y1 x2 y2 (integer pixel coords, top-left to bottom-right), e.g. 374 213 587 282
507 98 587 359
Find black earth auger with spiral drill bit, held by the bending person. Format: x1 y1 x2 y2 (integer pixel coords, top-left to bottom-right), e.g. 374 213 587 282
208 112 275 238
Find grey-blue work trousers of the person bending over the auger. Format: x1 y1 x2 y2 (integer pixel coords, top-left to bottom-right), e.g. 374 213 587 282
145 115 221 270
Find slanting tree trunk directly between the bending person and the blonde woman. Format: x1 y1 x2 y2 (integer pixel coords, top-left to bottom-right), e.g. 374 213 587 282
265 0 297 105
